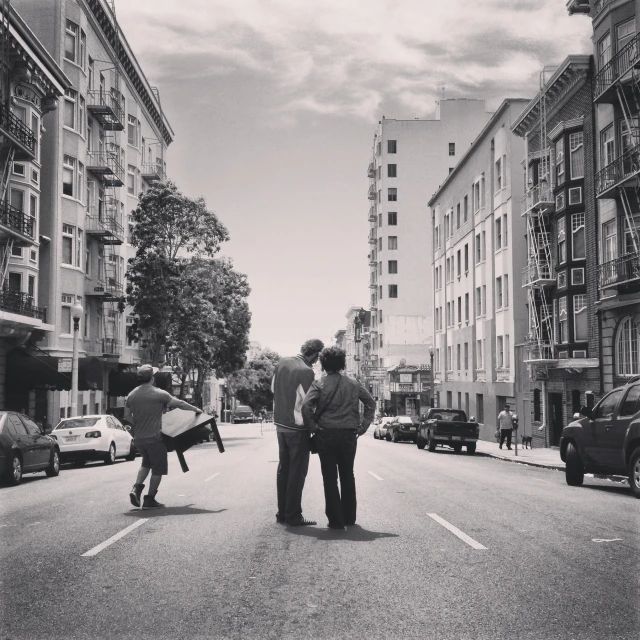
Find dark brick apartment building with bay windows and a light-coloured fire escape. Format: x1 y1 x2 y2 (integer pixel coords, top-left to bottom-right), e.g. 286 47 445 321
513 55 600 446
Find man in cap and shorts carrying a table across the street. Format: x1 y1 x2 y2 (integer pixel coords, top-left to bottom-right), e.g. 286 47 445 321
124 364 202 509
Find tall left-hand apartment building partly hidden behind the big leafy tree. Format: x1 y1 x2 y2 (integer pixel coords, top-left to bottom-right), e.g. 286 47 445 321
13 0 173 424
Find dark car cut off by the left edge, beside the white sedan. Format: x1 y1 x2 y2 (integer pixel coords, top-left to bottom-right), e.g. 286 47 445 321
0 411 60 485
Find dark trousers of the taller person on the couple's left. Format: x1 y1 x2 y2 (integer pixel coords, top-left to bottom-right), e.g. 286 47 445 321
276 430 309 522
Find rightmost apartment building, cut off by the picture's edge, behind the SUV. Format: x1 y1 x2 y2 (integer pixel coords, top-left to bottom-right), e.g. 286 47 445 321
567 0 640 392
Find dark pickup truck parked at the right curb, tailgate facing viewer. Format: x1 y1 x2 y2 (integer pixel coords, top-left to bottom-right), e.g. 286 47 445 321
416 408 480 455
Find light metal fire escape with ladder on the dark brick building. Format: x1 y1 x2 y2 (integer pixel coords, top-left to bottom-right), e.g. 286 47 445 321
522 70 555 363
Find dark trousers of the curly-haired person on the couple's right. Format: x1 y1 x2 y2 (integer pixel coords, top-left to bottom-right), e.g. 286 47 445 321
316 429 358 527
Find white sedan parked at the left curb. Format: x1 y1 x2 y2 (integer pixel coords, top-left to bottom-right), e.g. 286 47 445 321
51 415 136 466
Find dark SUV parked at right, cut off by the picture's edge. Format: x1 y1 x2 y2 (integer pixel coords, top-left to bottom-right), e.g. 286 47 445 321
560 379 640 498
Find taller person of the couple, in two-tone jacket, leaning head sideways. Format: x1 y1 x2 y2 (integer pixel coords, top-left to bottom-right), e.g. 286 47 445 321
271 339 324 527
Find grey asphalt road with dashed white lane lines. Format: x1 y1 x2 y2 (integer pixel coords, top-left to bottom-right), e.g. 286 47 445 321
0 425 640 640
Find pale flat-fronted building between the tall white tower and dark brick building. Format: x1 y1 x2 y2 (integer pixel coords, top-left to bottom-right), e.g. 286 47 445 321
429 99 528 440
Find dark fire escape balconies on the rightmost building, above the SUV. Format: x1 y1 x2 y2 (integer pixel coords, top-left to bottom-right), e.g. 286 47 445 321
593 30 640 290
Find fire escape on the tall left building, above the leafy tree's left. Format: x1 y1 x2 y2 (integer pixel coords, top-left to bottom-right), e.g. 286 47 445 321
86 0 125 358
